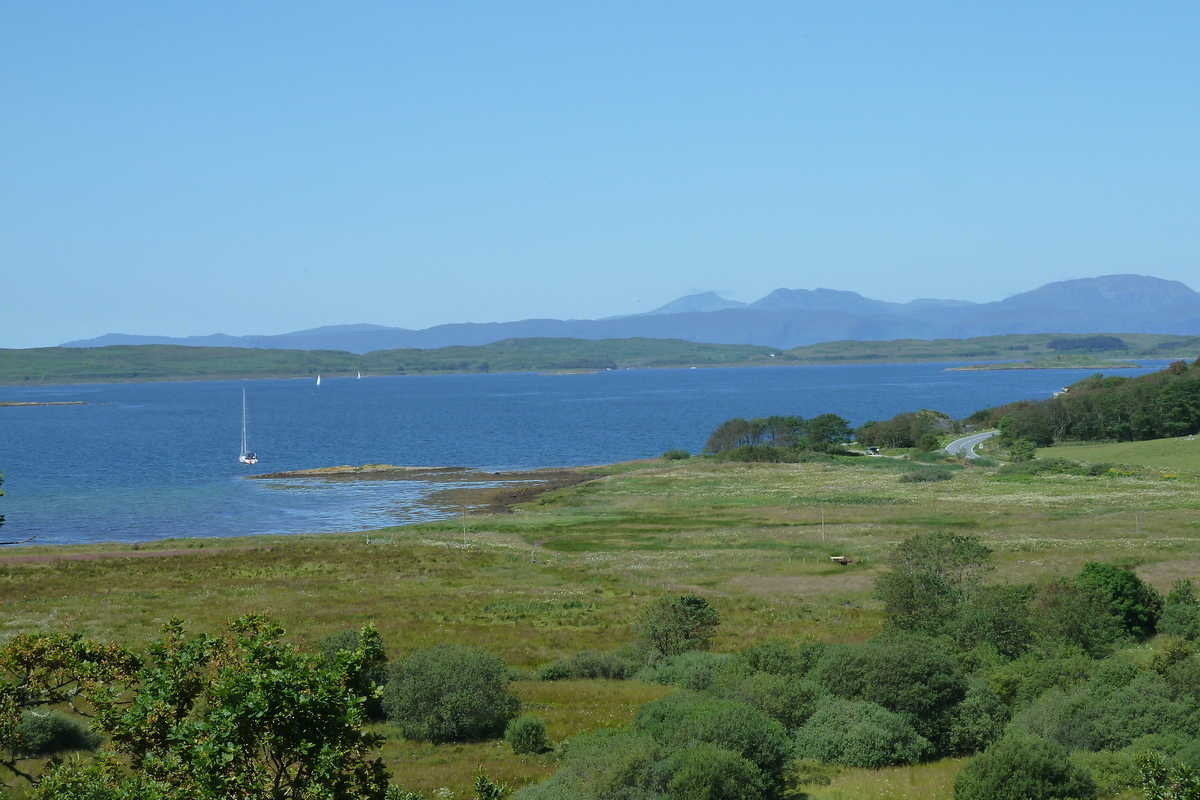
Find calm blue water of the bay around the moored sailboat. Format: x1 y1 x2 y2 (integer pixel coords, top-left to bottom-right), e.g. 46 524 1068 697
0 365 1160 545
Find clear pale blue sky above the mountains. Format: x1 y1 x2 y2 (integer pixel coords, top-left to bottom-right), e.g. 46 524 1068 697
0 0 1200 347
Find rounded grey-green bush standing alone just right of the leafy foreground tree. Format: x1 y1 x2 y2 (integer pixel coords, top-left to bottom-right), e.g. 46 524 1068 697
383 644 521 744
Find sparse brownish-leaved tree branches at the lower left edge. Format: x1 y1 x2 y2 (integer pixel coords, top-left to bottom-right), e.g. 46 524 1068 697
0 632 139 782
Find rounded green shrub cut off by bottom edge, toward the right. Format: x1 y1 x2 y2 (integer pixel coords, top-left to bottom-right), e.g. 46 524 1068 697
954 736 1096 800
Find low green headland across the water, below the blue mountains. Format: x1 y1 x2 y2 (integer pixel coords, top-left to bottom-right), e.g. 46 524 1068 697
0 333 1200 386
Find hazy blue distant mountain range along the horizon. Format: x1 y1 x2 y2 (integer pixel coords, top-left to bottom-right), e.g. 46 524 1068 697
62 275 1200 353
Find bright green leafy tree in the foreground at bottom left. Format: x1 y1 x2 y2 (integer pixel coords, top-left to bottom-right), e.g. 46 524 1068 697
90 614 388 800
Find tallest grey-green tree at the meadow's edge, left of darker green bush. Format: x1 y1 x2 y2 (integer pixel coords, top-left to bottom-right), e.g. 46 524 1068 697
875 531 992 632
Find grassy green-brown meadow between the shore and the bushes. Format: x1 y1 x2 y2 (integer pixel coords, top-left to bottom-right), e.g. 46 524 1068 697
0 443 1200 800
